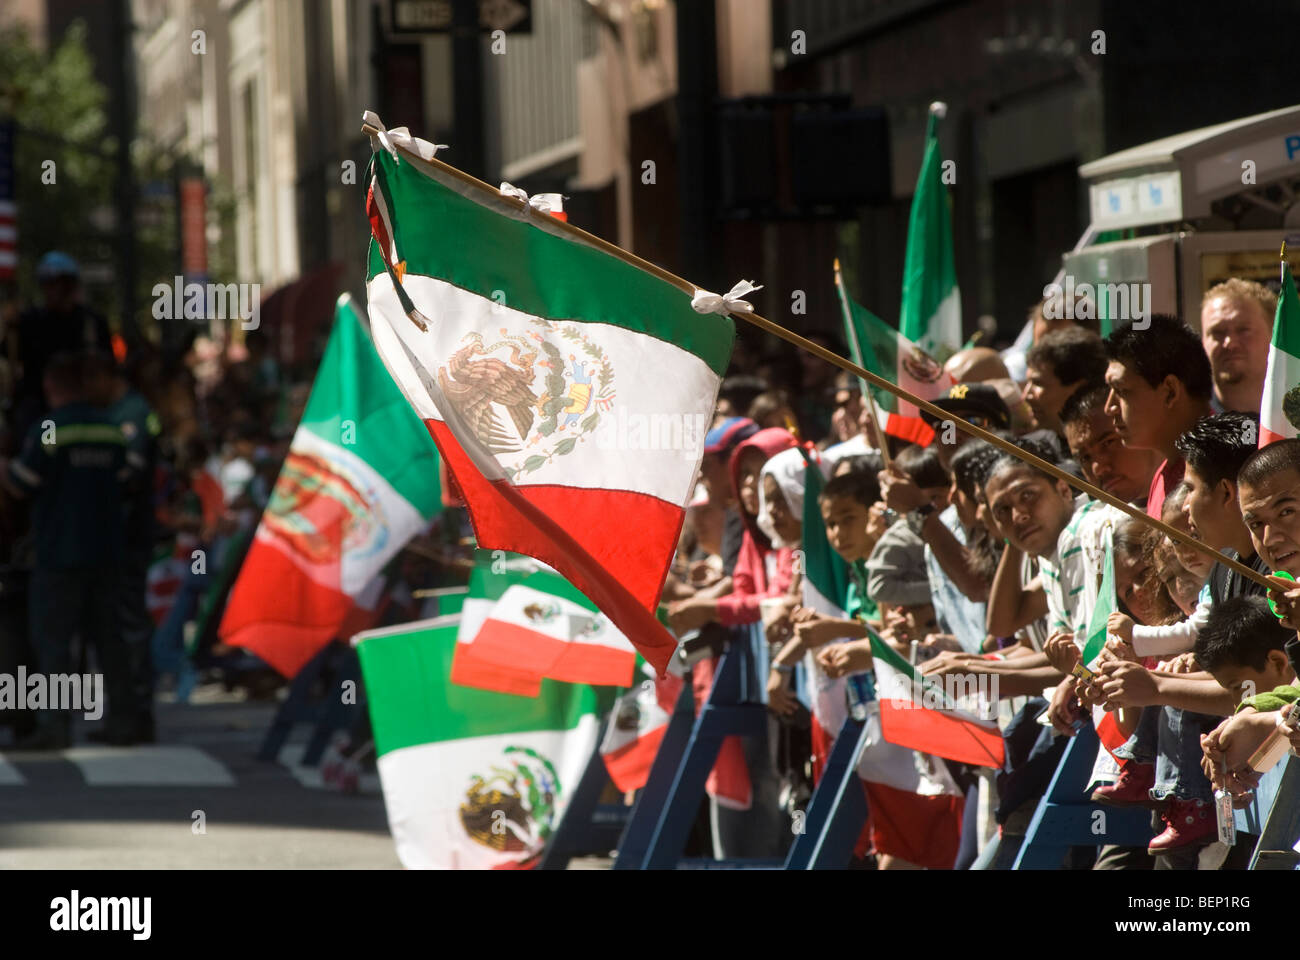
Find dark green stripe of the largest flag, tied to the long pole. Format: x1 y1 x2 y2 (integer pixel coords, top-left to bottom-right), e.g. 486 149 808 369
368 150 736 376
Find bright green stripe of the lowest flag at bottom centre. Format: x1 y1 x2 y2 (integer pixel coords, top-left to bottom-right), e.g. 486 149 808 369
356 620 616 756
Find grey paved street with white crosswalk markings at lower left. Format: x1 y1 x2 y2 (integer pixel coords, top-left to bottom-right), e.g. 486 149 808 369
0 687 400 870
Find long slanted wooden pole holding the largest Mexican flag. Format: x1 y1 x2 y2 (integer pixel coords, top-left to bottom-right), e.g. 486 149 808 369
361 124 1277 589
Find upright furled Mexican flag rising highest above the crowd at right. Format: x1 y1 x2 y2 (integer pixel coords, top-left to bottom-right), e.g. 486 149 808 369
898 104 962 360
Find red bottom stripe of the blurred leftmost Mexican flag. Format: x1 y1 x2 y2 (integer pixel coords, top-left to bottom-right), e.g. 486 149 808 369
220 537 352 676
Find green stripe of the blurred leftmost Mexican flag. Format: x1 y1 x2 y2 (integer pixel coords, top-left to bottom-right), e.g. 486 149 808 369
302 297 442 518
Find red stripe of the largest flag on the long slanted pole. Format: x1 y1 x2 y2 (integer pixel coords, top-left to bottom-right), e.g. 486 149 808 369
425 420 684 674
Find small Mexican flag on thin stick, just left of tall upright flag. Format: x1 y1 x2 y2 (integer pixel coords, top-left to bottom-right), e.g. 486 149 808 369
835 260 953 446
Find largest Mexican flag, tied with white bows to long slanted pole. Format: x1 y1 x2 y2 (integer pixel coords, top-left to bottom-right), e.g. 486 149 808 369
367 115 735 673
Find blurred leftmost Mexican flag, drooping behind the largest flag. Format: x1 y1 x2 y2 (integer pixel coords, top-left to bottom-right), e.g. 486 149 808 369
220 294 442 676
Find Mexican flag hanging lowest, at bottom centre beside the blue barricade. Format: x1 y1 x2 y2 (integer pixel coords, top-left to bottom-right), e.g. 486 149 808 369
352 615 603 869
